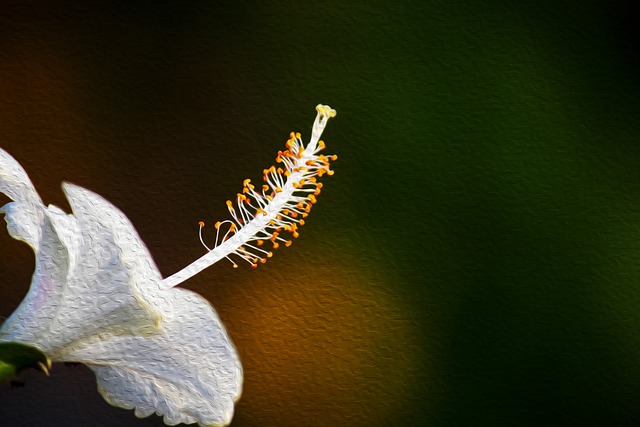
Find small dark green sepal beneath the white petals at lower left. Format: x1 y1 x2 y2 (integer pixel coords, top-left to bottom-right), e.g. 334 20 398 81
0 342 51 382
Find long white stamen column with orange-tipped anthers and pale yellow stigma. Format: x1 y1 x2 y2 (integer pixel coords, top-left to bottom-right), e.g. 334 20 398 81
163 105 337 286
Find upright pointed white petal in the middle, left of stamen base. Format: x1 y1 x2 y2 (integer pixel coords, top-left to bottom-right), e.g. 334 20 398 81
43 184 171 360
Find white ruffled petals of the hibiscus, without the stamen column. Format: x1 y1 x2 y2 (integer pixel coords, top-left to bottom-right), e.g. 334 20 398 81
0 146 242 426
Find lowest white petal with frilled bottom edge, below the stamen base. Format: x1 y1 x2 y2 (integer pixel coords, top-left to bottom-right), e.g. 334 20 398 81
66 288 242 426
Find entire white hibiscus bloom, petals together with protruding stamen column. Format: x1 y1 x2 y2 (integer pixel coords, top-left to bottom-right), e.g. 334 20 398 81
0 106 335 426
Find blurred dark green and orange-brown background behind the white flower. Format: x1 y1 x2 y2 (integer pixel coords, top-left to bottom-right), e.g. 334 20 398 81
0 0 640 427
